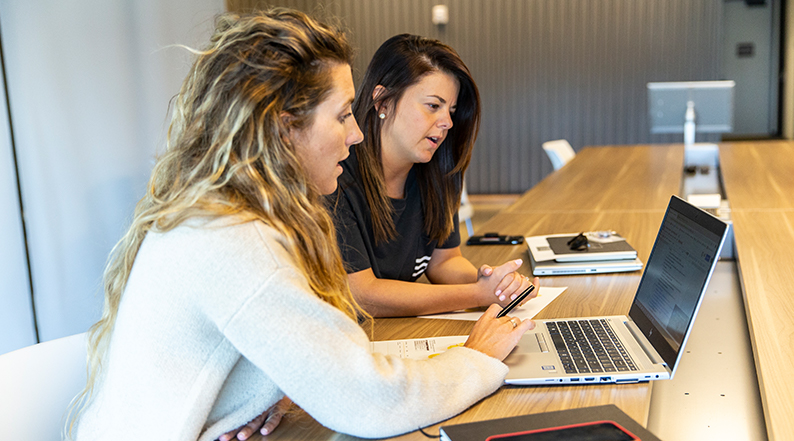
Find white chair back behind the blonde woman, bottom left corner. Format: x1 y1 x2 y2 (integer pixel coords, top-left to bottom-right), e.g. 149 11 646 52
0 333 86 441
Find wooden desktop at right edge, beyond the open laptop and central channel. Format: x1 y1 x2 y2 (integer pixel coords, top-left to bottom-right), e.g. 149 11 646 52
720 141 794 440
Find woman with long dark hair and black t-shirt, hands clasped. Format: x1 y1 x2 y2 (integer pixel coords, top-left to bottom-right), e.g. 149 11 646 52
331 34 537 316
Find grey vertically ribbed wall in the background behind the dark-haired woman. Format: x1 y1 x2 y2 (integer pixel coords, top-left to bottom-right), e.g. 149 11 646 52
230 0 722 193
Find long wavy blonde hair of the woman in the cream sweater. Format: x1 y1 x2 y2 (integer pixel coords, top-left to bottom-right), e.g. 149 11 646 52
65 9 368 438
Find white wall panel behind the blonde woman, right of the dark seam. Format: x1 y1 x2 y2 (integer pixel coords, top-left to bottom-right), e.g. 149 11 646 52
0 0 223 340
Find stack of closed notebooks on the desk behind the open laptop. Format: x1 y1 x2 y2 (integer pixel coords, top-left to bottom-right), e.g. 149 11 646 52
525 231 642 276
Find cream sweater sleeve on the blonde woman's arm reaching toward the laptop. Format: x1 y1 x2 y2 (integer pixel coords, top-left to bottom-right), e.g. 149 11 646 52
213 267 507 438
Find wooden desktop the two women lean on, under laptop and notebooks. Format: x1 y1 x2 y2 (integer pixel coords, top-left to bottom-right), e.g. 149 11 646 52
254 145 684 440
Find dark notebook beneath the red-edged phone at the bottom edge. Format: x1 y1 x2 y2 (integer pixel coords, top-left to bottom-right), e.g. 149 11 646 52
440 404 660 441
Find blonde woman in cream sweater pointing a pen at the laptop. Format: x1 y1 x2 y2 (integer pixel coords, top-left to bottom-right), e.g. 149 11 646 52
69 10 533 441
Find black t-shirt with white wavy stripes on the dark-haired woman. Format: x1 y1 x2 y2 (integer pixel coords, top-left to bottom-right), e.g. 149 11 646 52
329 148 460 282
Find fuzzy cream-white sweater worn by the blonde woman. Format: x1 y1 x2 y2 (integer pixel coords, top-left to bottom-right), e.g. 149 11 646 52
77 221 507 441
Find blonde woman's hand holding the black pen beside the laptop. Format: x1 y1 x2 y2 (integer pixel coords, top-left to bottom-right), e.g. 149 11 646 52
464 304 535 360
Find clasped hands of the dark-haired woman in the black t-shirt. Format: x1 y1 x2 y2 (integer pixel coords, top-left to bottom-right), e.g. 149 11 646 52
477 259 540 306
